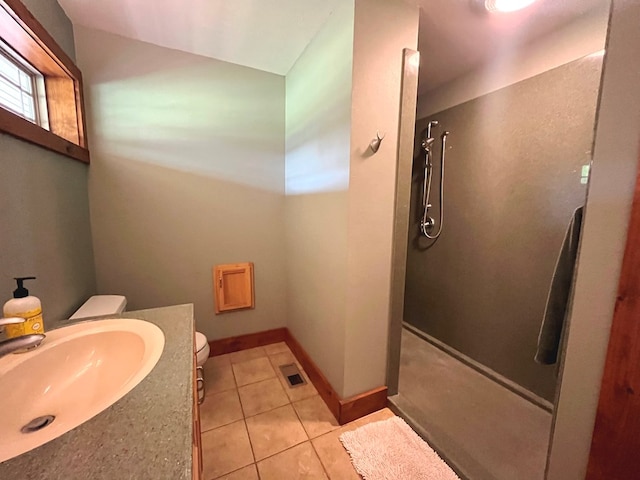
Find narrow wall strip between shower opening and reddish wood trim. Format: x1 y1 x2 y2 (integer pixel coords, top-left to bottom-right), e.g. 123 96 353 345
546 0 640 480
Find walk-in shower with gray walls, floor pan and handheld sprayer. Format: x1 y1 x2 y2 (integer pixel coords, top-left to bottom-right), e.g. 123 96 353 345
390 47 602 480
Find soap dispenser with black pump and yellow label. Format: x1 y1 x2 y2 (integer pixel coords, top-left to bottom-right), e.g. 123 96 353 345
2 277 44 338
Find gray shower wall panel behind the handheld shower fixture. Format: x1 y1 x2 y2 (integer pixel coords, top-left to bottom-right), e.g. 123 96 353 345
404 57 602 401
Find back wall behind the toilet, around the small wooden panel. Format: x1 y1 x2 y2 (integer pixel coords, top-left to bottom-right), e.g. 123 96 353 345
75 27 286 339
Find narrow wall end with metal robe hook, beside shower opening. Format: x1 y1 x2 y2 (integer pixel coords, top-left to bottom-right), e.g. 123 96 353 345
342 0 418 397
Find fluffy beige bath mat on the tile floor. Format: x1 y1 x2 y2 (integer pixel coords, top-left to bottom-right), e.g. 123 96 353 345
340 417 460 480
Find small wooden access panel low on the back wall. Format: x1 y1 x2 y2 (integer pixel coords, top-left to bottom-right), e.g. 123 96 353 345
213 262 255 314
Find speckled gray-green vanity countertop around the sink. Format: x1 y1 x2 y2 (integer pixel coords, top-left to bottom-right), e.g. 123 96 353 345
0 304 193 480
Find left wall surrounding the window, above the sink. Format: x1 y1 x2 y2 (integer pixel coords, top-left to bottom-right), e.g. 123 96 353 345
0 0 96 328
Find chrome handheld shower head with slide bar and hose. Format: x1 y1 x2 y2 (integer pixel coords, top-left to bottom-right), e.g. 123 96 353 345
420 120 449 240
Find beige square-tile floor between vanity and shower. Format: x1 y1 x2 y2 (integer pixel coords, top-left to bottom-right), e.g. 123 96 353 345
200 342 393 480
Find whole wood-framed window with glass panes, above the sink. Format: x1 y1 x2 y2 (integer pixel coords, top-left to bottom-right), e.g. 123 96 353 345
0 0 89 163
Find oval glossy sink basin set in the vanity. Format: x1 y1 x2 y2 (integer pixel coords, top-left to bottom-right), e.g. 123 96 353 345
0 319 164 462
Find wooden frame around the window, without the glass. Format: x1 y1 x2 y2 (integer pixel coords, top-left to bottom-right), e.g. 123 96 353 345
0 0 89 163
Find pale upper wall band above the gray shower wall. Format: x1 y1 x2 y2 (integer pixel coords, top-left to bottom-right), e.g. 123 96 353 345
417 5 609 118
